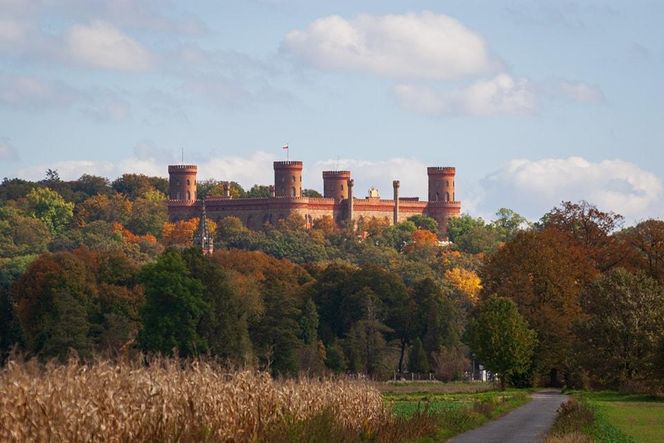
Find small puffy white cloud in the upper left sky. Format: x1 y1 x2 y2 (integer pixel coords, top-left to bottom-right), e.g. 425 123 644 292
64 21 152 71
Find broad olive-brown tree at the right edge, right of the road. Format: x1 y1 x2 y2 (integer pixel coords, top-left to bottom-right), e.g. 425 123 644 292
577 268 664 385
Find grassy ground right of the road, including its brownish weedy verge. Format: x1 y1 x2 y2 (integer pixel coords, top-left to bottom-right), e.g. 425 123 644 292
549 392 664 443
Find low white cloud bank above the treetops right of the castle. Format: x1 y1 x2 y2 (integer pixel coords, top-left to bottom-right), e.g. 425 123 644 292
479 157 664 220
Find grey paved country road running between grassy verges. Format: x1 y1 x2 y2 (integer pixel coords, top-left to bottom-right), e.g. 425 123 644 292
448 391 567 443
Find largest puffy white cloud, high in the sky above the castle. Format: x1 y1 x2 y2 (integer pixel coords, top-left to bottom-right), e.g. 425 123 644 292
283 11 496 80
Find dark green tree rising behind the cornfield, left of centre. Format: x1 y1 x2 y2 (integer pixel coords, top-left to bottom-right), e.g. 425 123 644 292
138 250 207 356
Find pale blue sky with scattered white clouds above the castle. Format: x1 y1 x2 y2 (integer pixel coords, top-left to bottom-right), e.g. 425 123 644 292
0 0 664 224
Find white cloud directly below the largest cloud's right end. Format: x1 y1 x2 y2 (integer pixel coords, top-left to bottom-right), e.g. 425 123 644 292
394 74 535 115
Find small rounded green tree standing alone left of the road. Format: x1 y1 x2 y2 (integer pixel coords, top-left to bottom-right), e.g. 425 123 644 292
468 296 537 390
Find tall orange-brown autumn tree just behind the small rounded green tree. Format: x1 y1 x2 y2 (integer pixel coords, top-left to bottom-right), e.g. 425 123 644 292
481 229 596 383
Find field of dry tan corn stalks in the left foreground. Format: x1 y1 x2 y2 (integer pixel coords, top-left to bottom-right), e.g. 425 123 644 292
0 360 391 442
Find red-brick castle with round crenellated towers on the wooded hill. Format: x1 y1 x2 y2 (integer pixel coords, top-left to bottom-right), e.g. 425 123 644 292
168 161 461 238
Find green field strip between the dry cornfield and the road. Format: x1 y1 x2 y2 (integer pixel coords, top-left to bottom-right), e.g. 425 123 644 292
381 383 530 441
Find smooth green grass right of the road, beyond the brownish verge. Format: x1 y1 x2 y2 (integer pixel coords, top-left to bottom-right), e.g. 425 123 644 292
583 392 664 443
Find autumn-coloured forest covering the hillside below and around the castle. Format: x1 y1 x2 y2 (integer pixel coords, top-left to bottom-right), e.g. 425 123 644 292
0 170 664 387
